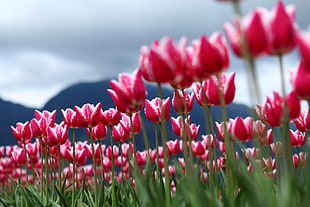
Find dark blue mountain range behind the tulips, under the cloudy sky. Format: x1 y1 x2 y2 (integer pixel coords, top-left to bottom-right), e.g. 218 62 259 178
0 80 249 148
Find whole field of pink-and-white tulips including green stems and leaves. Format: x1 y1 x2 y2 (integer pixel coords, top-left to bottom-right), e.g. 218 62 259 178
0 0 310 207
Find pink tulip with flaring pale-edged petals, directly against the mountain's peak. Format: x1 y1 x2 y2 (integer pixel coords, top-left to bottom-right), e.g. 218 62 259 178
108 70 146 113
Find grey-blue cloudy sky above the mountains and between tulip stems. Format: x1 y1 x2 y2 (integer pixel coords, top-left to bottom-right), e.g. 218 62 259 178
0 0 310 108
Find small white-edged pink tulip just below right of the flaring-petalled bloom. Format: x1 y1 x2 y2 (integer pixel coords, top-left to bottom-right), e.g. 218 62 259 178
144 97 170 124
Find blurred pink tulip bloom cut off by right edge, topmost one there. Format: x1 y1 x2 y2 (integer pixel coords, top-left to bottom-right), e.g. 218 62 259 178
297 28 310 68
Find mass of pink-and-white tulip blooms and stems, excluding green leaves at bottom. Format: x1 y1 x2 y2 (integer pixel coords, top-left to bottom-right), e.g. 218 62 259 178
0 1 310 205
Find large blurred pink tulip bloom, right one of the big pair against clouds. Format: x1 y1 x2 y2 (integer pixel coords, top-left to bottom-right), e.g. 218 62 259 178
190 32 229 81
